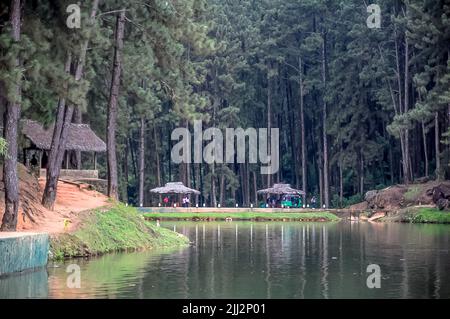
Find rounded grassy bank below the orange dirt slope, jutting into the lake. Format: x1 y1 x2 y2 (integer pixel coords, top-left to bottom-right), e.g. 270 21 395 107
50 204 189 259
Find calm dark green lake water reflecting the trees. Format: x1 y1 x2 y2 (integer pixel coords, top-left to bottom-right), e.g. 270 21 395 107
0 222 450 299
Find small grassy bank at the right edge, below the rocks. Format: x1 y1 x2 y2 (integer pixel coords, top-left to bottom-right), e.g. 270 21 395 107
382 207 450 224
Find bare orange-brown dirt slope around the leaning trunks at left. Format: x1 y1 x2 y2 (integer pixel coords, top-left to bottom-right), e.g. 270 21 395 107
0 164 111 234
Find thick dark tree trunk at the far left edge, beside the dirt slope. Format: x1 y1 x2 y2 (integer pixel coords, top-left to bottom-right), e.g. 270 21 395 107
0 0 22 231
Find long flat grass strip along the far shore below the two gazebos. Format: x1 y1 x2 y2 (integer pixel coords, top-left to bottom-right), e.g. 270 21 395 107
144 212 339 222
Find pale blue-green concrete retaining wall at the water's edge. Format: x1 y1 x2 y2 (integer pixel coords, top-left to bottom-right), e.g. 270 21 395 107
0 233 49 276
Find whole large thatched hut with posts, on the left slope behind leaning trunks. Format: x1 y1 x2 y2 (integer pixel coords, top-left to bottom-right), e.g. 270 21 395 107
21 119 106 176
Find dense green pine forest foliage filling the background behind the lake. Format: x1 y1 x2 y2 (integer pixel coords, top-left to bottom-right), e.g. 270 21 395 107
0 0 450 207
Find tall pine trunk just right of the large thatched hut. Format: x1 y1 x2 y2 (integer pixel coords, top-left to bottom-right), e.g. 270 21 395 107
106 10 125 199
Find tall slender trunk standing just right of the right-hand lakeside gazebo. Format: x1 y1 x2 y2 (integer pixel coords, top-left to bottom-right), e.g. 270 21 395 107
322 35 330 208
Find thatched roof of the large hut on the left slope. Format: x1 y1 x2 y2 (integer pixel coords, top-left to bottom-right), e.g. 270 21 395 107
21 120 106 153
